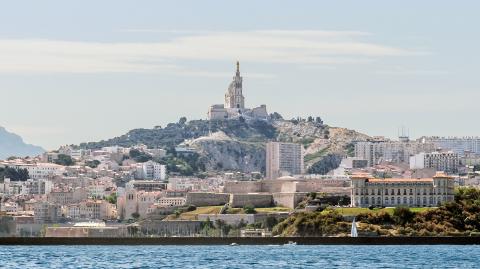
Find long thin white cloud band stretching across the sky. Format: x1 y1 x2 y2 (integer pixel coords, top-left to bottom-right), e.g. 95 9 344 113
0 29 417 73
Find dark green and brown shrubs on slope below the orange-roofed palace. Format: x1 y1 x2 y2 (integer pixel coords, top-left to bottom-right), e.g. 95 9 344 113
273 185 480 236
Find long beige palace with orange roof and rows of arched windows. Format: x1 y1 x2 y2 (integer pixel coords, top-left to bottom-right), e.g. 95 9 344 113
351 173 454 207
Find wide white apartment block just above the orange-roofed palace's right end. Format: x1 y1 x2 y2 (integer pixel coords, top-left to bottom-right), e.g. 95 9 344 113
410 151 460 173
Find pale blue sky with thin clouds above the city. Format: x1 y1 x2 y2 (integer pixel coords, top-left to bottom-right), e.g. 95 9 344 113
0 0 480 149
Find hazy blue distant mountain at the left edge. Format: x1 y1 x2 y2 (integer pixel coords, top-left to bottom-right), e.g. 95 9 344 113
0 126 45 160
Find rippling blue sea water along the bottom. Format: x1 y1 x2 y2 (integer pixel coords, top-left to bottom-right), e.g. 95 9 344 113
0 246 480 269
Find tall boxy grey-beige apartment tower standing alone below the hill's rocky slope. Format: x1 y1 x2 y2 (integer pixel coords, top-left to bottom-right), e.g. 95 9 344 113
266 142 304 179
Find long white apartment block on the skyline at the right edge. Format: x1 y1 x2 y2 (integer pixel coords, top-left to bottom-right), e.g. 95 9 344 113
421 137 480 156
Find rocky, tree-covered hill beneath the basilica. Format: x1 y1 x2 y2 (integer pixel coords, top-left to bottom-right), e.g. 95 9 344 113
80 113 369 173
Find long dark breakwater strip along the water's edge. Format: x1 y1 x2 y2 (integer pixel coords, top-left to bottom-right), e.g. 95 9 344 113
0 237 480 245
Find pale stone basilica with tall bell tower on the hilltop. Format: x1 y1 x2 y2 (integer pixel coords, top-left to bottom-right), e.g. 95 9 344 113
208 61 268 120
